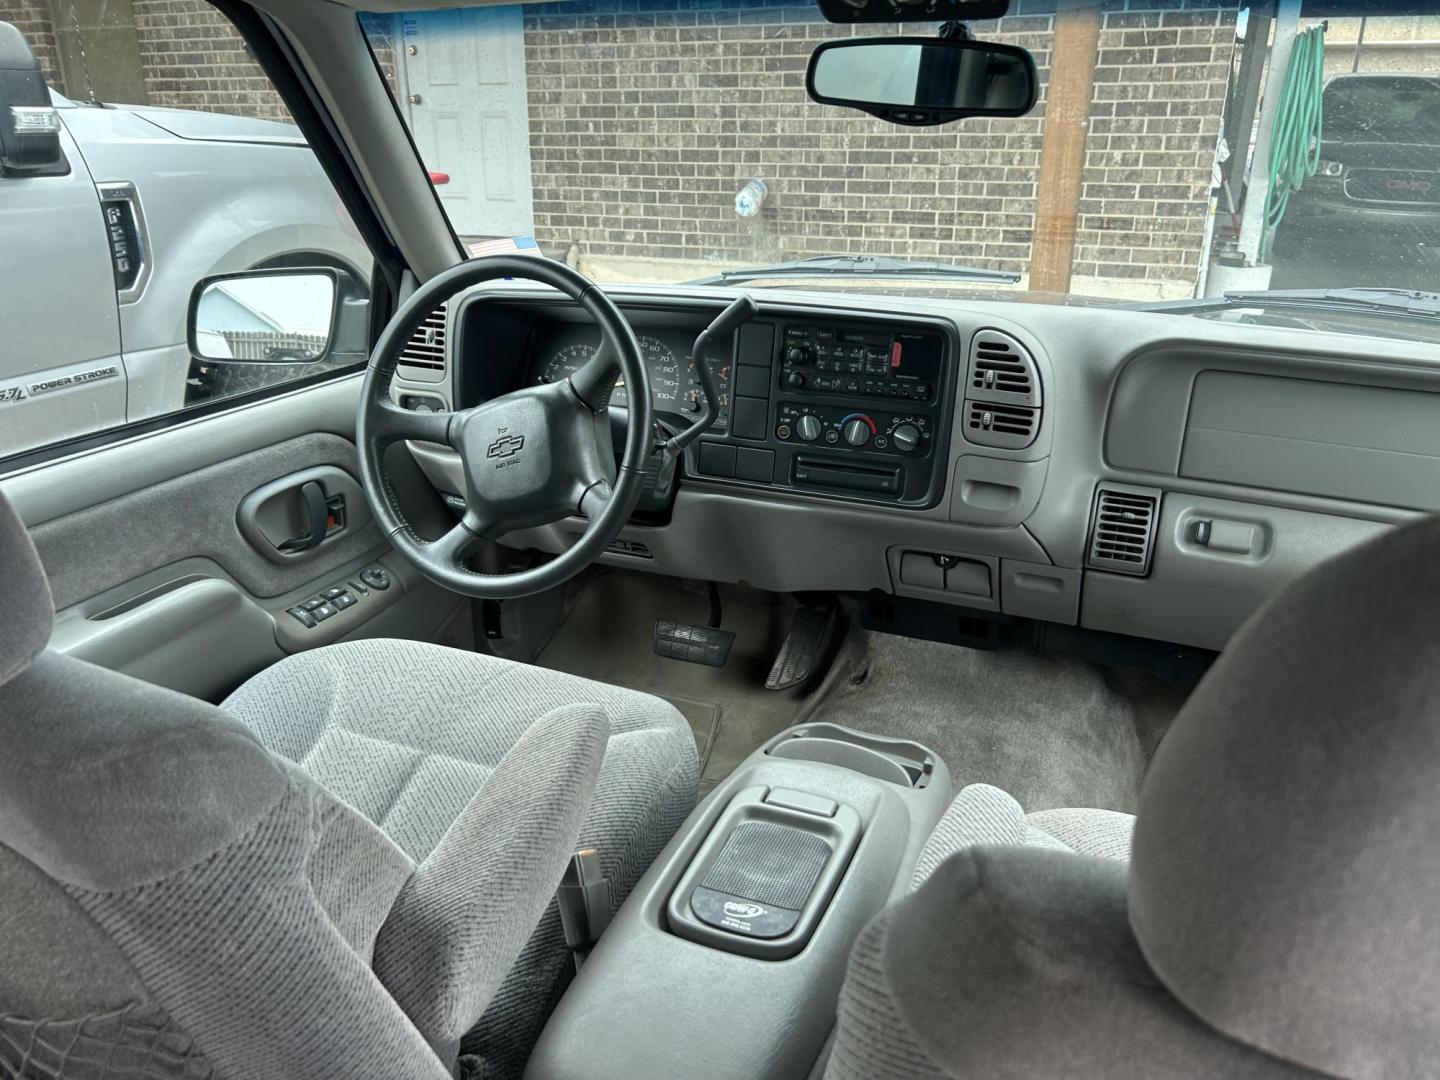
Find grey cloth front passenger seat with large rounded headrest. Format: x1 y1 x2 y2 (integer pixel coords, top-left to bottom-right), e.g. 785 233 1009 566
827 518 1440 1080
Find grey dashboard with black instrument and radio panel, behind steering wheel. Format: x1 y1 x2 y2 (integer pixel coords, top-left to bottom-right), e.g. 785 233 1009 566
396 284 1440 659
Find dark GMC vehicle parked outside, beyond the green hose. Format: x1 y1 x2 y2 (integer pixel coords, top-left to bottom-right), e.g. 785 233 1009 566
1282 73 1440 252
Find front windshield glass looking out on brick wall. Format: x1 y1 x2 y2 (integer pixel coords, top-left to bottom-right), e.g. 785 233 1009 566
363 0 1440 325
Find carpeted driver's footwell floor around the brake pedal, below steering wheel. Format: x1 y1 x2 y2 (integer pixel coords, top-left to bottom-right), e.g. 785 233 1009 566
536 569 805 792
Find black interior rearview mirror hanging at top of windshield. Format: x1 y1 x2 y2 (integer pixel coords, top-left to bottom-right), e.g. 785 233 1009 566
805 37 1038 125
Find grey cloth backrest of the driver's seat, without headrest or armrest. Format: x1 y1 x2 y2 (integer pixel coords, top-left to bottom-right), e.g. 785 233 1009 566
0 652 448 1080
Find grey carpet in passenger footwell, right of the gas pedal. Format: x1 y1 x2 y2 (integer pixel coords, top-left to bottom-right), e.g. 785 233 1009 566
805 631 1184 812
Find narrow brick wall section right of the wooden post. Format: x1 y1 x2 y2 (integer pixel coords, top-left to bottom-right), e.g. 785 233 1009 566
1074 0 1236 281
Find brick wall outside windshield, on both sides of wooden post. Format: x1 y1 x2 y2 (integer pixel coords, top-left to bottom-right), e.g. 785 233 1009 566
526 0 1234 288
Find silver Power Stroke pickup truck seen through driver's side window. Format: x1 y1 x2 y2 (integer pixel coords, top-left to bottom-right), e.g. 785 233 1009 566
0 23 372 456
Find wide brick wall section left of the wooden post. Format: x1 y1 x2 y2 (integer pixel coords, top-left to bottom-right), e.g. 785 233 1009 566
526 0 1053 279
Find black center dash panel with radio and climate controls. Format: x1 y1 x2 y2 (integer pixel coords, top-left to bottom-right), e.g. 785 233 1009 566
688 318 953 507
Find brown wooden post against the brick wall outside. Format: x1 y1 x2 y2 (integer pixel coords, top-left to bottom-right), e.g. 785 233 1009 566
1030 0 1100 292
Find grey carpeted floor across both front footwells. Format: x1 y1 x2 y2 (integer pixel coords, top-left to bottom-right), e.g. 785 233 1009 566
537 570 1185 811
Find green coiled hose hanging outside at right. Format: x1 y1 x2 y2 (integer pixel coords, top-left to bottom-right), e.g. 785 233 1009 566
1260 24 1325 262
